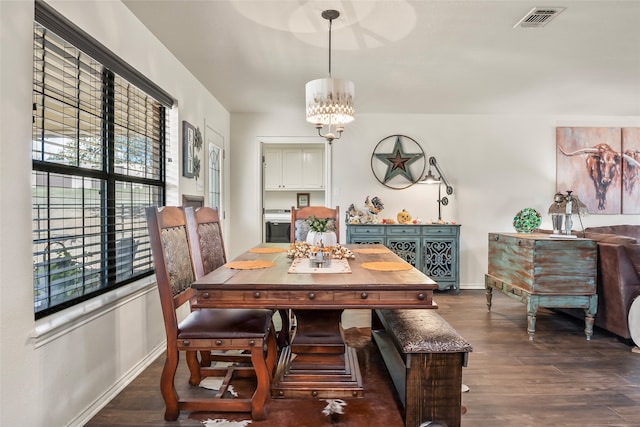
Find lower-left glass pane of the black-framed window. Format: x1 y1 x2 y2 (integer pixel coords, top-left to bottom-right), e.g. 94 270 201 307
32 171 104 312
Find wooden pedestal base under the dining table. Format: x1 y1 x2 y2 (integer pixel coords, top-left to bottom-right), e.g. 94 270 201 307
271 310 363 398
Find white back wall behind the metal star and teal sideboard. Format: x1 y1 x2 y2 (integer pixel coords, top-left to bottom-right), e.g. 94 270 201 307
228 113 640 289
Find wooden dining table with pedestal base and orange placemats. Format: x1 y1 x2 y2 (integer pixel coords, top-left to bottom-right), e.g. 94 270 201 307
193 243 438 398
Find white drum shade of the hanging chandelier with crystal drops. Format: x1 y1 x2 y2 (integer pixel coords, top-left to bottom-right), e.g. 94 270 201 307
305 78 354 126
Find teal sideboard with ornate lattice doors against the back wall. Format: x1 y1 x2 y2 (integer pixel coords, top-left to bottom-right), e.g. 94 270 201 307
347 224 460 293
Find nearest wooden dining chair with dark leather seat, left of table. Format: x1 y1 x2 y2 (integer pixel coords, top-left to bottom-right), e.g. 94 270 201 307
146 206 276 421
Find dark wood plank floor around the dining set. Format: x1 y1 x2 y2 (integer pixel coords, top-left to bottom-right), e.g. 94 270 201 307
87 290 640 427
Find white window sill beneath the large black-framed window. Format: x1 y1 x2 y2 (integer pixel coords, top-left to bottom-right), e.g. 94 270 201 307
29 275 156 348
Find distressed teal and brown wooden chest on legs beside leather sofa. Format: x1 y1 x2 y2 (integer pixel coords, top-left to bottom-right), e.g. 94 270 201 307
485 233 598 340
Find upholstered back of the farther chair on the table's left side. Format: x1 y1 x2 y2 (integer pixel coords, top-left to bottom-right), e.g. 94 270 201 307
185 207 227 279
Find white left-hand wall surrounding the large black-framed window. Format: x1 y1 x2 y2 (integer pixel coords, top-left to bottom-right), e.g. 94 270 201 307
0 0 230 427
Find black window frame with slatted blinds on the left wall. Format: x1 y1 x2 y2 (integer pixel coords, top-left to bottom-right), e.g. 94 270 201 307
32 0 173 320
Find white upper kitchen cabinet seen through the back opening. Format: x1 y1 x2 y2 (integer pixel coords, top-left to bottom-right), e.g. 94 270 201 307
264 148 325 190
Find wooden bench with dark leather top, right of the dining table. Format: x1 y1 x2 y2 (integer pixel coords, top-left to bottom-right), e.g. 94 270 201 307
371 309 472 427
